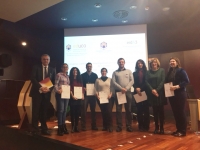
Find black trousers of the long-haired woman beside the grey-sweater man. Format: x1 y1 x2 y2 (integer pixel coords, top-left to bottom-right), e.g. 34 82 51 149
136 102 150 130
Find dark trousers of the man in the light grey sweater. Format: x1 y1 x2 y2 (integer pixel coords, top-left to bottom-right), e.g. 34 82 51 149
115 91 133 128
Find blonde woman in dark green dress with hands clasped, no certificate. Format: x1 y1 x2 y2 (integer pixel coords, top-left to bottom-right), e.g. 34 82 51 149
145 58 167 134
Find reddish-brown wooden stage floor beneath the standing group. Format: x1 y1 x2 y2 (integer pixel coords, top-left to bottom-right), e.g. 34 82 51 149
38 113 200 150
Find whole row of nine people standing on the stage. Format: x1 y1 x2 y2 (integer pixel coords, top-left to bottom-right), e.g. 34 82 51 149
30 54 189 137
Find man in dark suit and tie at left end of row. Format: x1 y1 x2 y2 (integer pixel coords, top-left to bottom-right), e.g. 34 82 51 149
30 54 56 135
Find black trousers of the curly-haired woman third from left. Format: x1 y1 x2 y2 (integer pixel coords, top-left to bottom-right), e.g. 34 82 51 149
70 105 81 127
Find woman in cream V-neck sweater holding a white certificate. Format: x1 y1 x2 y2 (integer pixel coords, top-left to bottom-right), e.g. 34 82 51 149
95 68 114 132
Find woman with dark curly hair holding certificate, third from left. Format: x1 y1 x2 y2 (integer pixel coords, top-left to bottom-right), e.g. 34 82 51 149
69 67 84 133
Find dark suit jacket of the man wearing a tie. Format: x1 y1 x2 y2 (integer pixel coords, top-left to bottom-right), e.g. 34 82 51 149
30 65 56 97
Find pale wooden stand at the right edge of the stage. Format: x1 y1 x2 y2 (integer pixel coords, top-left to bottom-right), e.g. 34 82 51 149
187 99 200 131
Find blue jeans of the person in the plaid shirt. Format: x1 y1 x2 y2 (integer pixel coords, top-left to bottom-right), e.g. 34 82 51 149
56 93 69 125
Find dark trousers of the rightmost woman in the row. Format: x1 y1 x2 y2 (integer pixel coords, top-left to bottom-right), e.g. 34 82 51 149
169 91 187 133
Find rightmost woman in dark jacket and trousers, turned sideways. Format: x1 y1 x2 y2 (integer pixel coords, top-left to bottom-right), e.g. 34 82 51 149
166 57 189 137
